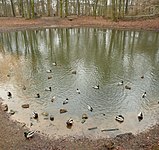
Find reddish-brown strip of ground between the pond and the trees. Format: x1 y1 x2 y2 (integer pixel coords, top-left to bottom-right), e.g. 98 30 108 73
0 17 159 32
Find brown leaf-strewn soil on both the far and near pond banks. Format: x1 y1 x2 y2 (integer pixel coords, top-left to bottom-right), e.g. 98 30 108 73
0 17 159 150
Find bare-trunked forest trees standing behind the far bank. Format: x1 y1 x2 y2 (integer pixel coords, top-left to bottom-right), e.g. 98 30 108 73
0 0 159 21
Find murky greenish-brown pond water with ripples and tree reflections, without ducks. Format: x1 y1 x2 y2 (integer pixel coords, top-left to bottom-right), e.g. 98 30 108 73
0 28 159 138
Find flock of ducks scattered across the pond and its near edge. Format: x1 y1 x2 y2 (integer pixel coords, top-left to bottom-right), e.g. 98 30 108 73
7 63 146 139
